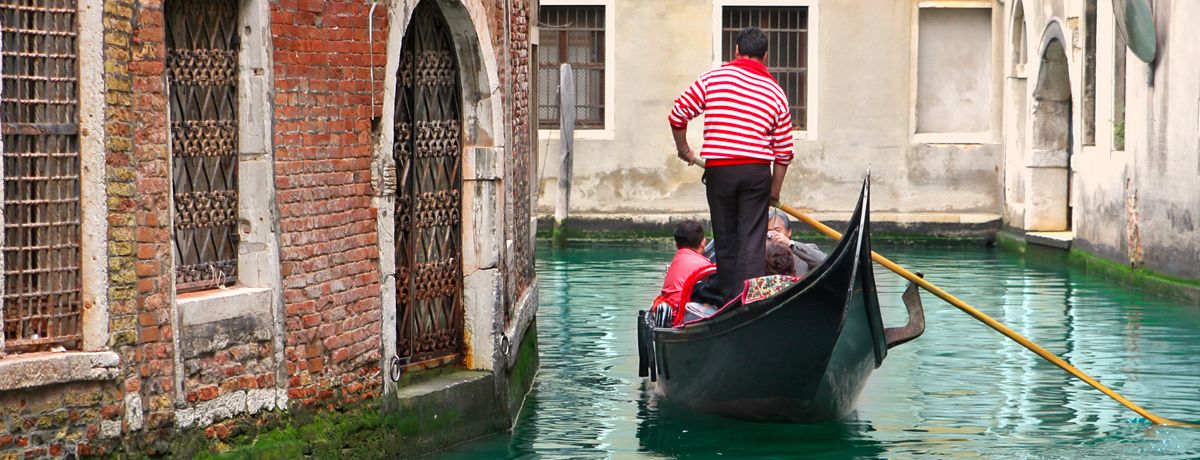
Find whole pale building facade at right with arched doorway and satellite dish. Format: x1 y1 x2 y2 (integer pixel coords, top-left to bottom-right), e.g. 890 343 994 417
1003 0 1200 280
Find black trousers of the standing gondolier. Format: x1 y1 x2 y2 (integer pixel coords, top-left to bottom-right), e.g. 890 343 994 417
704 165 770 301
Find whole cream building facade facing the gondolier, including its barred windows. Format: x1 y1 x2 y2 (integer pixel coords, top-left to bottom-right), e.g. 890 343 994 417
538 0 1004 231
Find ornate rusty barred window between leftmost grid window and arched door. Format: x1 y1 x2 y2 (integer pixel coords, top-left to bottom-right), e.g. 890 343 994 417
164 0 239 292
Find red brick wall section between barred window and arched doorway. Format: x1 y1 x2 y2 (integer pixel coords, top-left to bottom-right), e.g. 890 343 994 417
271 0 388 405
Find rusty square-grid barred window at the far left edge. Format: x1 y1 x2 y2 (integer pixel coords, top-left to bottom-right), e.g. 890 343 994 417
0 0 82 353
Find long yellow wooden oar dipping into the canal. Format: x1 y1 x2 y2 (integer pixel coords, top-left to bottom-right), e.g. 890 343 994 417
775 203 1200 428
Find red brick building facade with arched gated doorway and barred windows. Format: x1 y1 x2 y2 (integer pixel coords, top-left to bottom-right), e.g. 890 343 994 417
0 0 536 458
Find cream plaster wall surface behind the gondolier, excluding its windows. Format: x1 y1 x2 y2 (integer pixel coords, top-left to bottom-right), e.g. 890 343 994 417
538 0 1004 215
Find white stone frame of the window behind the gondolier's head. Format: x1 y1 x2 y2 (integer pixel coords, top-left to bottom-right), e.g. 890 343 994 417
712 0 821 141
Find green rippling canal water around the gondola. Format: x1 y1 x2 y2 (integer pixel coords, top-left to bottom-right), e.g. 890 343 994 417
446 244 1200 459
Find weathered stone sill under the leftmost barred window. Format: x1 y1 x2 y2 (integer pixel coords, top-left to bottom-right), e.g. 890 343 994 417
0 352 121 392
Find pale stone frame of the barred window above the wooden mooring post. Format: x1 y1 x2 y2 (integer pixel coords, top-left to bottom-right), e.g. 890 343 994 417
530 0 617 141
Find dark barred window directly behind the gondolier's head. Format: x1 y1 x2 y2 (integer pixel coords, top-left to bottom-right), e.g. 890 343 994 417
721 6 809 130
